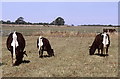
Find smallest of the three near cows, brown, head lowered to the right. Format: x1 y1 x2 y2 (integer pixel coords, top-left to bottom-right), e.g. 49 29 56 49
37 36 54 58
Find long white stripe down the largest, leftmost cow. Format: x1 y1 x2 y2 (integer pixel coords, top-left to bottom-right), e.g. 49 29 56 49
11 32 18 63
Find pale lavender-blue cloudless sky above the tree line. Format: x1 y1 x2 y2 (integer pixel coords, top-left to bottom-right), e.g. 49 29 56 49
2 2 118 25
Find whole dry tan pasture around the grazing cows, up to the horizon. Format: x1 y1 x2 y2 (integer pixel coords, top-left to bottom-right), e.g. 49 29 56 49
0 26 118 77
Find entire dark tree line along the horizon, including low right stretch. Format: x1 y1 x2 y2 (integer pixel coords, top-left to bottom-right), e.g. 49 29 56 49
0 17 118 27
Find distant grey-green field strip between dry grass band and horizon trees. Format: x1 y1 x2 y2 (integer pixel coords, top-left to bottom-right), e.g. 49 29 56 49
2 25 117 35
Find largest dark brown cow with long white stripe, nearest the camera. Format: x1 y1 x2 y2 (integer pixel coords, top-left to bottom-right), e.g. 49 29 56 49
6 32 27 66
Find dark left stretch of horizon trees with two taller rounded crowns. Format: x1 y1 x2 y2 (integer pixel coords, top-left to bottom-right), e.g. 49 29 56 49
0 17 65 25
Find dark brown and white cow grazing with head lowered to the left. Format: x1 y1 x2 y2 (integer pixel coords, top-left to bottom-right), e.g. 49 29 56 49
89 32 110 56
